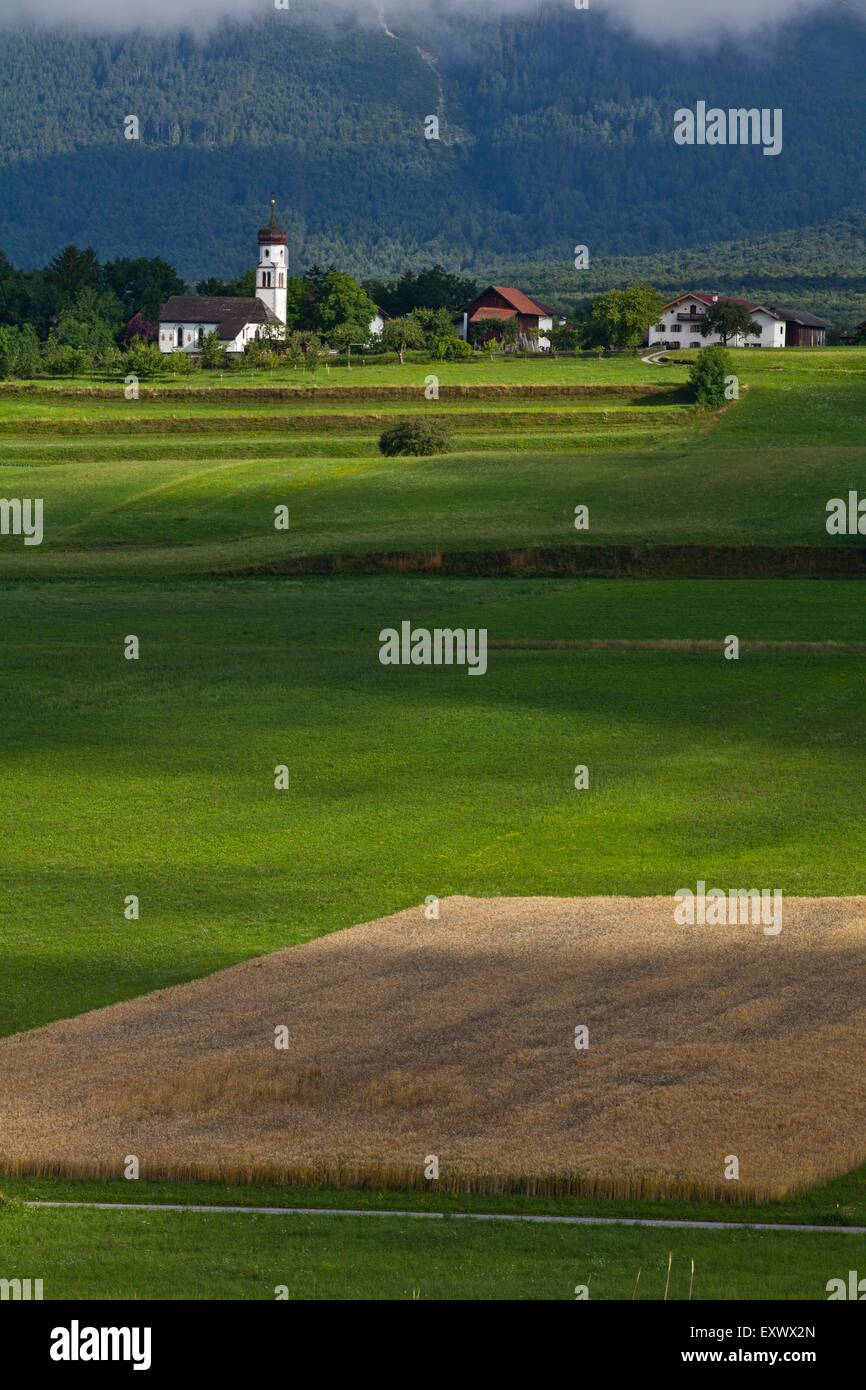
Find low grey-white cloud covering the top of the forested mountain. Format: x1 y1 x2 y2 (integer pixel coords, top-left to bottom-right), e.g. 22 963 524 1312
0 0 866 42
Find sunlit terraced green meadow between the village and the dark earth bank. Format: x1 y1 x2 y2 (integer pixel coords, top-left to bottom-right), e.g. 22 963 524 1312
0 349 866 580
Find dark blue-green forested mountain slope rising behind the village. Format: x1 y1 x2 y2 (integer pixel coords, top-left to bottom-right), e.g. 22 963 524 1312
0 0 866 279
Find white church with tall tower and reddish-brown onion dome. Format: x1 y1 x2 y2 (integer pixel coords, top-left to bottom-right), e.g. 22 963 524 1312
158 199 289 353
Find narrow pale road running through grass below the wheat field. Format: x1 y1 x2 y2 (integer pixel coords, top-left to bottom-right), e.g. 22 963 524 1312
24 1201 866 1236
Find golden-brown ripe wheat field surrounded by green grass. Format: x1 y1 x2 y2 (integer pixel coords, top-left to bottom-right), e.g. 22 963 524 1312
0 897 866 1201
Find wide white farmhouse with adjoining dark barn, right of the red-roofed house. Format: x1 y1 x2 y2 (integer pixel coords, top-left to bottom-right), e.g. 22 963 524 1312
648 291 828 349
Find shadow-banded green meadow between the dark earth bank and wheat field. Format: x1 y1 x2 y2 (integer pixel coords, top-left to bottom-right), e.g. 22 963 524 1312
0 578 866 1033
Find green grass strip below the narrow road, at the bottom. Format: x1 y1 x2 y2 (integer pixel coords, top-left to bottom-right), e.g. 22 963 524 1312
0 1205 865 1301
